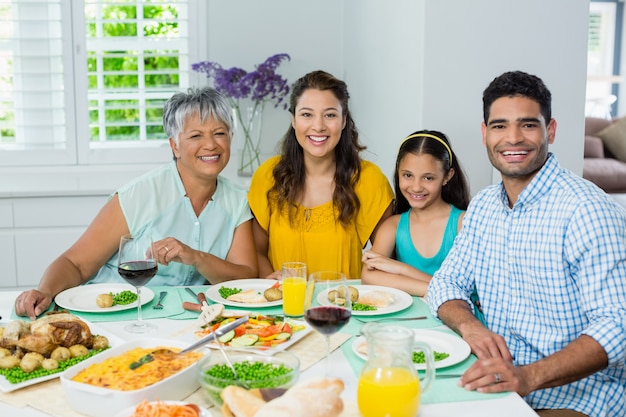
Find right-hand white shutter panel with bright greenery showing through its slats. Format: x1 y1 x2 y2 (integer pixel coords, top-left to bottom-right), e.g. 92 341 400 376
85 0 190 147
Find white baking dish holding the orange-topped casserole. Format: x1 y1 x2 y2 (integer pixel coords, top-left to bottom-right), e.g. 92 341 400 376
60 339 200 417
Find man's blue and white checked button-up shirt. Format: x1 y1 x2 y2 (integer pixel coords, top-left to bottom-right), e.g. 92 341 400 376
427 154 626 417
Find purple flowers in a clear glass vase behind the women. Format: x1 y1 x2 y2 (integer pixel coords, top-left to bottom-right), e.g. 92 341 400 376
191 54 291 175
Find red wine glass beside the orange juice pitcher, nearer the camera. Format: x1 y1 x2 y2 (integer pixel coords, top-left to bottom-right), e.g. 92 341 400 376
304 271 352 376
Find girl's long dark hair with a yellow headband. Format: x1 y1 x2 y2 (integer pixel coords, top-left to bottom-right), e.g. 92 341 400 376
393 130 470 214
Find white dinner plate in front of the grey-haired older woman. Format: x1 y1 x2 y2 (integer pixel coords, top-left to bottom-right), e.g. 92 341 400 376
54 283 154 313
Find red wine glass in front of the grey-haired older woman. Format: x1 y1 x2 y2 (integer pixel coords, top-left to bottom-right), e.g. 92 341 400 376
117 235 157 334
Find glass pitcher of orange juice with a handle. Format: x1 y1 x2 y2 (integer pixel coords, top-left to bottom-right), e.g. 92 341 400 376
357 322 435 417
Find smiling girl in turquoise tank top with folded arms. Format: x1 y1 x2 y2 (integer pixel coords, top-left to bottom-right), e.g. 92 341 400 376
362 130 470 296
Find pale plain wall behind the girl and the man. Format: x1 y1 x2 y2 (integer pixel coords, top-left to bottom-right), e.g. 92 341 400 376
345 0 589 193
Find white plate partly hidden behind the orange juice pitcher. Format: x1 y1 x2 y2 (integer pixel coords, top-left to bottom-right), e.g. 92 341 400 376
352 329 472 370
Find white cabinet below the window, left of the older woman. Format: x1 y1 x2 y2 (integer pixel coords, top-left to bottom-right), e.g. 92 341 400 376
0 193 108 290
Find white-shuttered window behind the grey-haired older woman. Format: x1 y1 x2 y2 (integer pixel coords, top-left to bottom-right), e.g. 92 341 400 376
0 0 200 166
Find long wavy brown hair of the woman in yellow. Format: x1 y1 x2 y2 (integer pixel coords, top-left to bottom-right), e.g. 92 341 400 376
267 71 365 227
